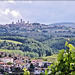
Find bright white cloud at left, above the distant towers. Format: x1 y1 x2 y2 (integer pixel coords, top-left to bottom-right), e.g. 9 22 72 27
0 8 22 23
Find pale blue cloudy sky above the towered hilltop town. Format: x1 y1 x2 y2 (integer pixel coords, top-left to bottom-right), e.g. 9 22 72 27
0 1 75 24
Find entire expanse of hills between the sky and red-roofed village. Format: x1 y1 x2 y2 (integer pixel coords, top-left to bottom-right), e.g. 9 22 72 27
0 22 75 56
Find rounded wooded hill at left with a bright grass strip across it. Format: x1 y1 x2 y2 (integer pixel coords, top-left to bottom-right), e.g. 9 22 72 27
0 36 52 57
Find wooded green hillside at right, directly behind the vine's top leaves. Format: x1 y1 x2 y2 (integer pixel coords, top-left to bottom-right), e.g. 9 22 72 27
42 37 75 53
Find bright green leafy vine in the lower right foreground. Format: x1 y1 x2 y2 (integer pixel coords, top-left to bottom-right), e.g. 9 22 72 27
45 42 75 75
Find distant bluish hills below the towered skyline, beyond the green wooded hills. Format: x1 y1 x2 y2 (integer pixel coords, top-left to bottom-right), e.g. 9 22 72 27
0 22 75 42
